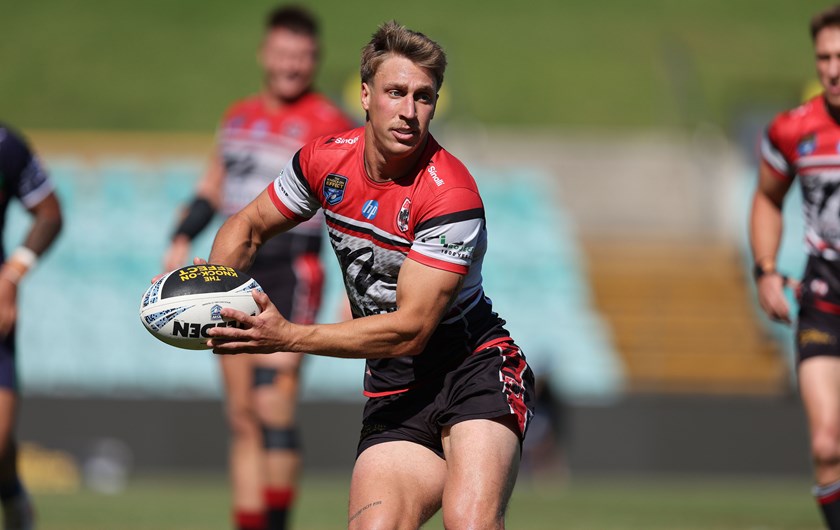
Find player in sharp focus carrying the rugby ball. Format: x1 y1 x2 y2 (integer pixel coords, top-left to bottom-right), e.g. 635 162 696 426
200 22 533 528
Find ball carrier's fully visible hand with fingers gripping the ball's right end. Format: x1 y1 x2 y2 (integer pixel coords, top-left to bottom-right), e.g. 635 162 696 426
207 291 292 355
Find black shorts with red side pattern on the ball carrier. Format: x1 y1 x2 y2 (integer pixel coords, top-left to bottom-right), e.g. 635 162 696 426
356 342 534 458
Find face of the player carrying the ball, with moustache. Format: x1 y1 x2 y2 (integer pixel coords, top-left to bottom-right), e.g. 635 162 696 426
362 55 437 157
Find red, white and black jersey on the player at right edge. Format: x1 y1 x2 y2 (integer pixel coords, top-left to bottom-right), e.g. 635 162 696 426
761 95 840 260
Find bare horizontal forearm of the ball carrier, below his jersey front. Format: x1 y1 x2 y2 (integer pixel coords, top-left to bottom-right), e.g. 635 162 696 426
289 311 434 359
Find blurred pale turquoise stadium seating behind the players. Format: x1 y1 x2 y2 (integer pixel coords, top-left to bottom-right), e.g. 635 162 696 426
5 157 623 399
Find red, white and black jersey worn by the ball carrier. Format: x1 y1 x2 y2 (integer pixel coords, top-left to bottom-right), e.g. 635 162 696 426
268 128 510 396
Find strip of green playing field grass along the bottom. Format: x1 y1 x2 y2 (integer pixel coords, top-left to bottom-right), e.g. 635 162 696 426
29 476 820 530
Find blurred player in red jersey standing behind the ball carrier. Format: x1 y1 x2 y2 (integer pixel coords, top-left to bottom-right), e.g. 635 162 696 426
164 7 353 530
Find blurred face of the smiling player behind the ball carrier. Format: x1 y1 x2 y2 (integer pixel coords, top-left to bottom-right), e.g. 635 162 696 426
259 28 318 101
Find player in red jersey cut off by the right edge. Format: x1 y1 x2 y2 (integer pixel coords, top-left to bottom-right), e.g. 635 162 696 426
750 6 840 530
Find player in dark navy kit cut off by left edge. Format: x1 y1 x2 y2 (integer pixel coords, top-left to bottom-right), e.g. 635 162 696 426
0 123 61 530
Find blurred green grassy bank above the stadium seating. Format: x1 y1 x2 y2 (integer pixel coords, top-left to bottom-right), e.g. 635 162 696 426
0 0 827 131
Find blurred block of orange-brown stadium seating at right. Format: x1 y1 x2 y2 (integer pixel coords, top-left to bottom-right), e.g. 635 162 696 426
587 241 788 393
